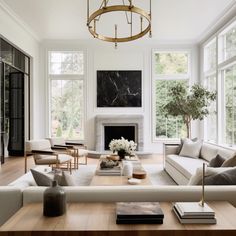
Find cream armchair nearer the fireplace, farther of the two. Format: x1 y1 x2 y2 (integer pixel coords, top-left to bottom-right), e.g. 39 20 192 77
49 137 88 169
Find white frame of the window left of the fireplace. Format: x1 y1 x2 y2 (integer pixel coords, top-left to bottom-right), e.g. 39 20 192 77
45 48 87 142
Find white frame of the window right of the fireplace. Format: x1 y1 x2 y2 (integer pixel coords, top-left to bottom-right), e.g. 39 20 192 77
151 48 192 143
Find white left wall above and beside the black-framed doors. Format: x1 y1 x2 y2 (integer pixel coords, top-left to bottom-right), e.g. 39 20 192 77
0 1 41 138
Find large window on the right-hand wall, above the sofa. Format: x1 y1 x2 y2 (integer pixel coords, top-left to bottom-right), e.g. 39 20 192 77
204 20 236 146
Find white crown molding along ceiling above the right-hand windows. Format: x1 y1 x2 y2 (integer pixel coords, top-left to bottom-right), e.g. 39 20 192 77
195 0 236 44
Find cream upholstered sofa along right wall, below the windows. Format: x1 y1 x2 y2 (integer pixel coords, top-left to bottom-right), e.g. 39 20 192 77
164 142 236 185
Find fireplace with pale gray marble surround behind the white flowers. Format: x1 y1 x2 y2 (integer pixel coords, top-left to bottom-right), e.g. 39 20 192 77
95 115 143 152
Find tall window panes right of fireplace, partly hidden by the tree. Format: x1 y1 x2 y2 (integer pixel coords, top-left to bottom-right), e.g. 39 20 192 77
153 51 190 139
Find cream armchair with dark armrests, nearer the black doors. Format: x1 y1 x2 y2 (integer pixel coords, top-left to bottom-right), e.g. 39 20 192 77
26 139 73 173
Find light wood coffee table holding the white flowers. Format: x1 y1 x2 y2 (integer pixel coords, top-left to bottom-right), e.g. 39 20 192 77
90 155 152 186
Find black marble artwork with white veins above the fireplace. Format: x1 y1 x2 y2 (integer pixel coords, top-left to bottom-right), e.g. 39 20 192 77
97 71 142 107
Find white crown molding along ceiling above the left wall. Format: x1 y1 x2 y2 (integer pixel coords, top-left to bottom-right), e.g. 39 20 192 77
0 0 41 42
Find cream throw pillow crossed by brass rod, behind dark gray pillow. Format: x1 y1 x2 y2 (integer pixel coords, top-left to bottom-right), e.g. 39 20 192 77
188 167 232 185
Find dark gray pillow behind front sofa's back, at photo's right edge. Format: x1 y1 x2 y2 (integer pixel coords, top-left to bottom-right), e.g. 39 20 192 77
205 168 236 185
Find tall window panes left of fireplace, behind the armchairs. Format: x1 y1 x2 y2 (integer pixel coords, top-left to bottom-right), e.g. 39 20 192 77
49 51 84 140
